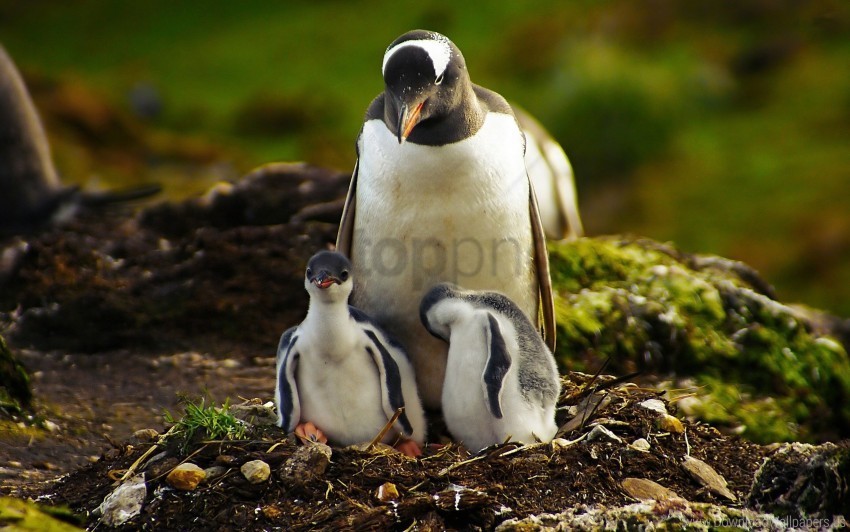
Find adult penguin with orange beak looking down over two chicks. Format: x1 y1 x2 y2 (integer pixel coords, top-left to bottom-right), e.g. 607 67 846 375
337 30 555 409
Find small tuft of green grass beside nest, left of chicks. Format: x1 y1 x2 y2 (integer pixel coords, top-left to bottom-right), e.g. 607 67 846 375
165 396 245 452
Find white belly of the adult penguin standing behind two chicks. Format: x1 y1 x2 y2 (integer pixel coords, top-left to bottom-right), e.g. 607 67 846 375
351 113 538 408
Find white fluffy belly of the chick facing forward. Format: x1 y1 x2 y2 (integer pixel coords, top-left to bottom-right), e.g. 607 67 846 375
296 344 388 445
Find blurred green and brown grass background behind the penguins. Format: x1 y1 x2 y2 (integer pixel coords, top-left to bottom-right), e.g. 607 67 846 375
0 0 850 316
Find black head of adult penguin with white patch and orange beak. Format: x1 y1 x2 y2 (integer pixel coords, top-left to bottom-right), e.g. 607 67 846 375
383 30 471 144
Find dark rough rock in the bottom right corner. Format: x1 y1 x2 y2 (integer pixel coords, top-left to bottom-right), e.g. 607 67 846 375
747 441 850 521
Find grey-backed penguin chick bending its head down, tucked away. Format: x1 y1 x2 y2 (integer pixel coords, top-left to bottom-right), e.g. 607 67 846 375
419 283 560 451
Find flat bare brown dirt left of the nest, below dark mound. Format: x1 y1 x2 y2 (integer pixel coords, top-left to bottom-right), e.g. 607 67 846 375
0 351 274 495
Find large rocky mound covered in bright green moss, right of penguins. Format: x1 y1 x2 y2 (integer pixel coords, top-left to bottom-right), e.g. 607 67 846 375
550 237 850 442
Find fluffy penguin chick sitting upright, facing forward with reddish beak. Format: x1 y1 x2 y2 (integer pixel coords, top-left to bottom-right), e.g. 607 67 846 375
275 251 426 456
